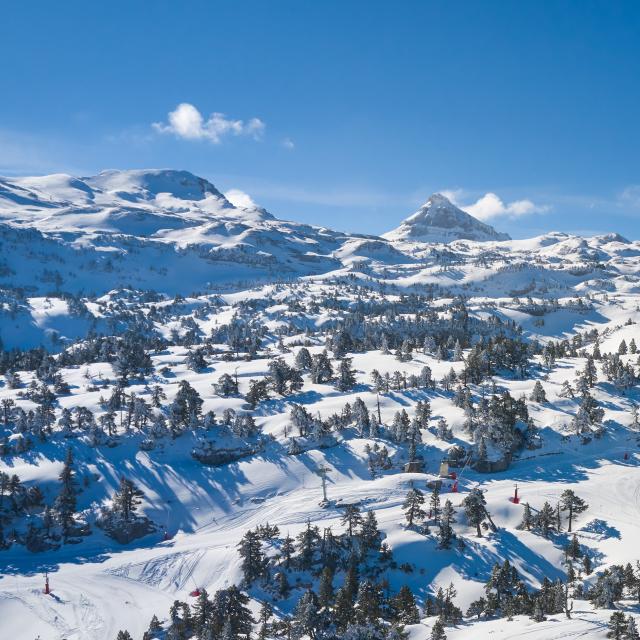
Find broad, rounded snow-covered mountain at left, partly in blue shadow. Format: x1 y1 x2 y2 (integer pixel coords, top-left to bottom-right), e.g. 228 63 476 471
0 170 372 293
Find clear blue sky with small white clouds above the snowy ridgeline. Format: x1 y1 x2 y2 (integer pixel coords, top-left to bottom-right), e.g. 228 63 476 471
0 0 640 238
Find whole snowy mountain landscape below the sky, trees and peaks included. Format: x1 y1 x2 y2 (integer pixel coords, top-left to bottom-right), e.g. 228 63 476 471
0 170 640 640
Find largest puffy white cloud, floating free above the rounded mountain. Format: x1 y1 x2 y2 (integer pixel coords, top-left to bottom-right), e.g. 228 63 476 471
152 102 265 144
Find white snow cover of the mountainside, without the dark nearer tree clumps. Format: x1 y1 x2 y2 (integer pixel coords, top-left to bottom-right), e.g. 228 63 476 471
0 170 640 640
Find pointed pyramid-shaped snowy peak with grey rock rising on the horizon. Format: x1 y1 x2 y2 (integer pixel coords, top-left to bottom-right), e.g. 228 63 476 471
383 193 510 243
